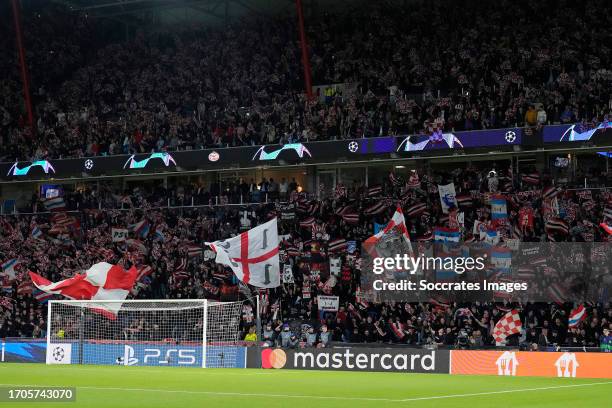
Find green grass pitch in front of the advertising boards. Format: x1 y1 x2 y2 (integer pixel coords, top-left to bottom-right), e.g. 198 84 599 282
0 363 612 408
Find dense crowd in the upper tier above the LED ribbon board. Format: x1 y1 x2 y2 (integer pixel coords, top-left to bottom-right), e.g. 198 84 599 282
0 0 612 161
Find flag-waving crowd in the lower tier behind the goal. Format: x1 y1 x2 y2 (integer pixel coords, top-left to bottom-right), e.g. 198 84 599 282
0 163 612 349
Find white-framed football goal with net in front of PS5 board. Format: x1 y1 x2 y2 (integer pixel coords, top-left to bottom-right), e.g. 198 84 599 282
47 300 246 368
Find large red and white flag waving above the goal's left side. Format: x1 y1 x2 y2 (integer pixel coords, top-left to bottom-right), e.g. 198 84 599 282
30 262 138 319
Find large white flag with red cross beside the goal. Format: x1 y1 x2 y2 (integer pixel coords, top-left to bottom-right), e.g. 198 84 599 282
206 218 280 288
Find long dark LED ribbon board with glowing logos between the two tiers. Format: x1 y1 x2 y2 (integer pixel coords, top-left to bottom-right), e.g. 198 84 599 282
0 126 612 182
